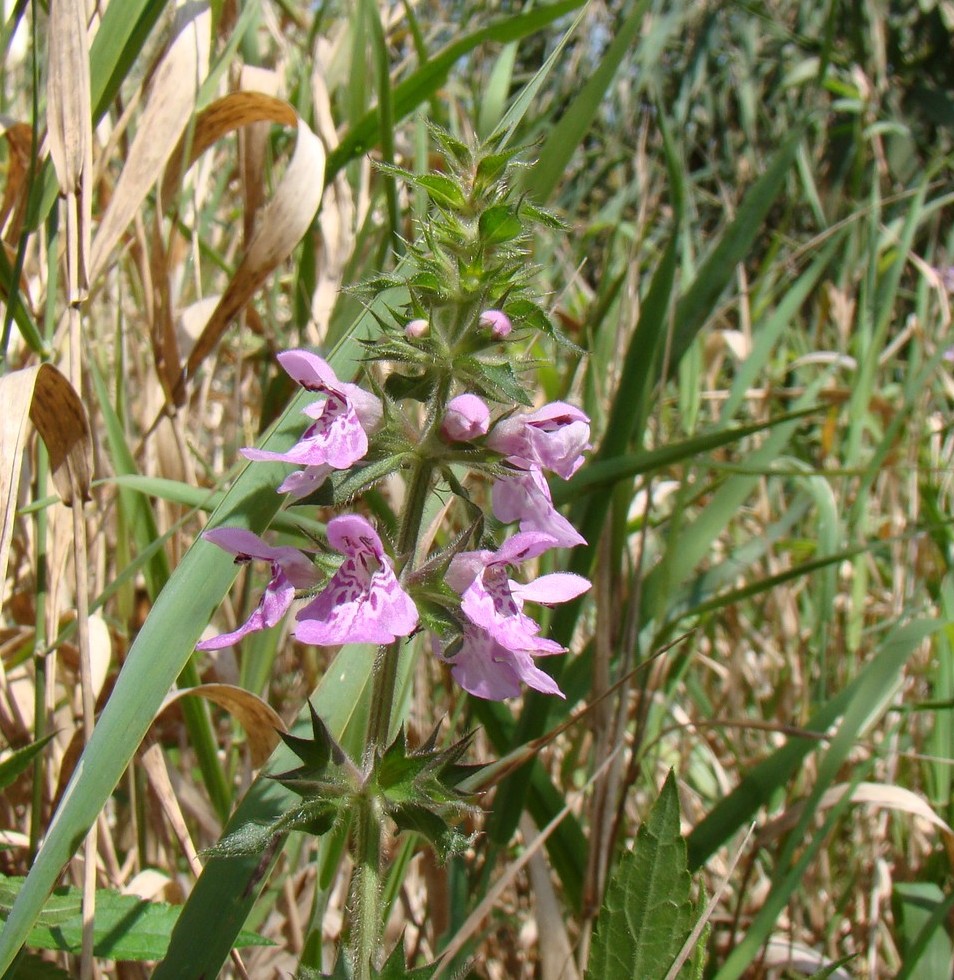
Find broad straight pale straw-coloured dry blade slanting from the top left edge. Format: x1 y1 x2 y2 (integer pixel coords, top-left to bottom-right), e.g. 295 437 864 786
90 4 211 278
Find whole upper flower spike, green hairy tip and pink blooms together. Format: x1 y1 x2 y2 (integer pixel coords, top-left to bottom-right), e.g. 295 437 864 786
199 134 590 700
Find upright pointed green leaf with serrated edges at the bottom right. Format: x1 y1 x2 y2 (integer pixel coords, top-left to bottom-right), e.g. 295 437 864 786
586 771 695 980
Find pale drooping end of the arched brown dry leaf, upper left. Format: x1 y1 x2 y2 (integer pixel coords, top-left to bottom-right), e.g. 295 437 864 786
175 119 325 404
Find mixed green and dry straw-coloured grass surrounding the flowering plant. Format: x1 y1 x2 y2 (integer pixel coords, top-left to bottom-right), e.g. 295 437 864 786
0 0 954 980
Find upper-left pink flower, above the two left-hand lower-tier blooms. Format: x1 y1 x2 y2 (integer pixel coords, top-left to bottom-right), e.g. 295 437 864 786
242 350 383 497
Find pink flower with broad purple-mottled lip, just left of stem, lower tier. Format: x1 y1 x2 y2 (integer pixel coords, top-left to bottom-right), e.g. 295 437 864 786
295 514 418 646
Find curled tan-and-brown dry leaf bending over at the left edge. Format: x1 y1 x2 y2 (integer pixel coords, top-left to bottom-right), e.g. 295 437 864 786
0 364 93 603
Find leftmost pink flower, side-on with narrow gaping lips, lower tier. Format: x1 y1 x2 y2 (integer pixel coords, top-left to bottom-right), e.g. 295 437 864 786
196 527 318 650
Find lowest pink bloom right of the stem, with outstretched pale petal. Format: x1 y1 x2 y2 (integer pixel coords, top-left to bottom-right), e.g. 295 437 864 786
442 531 590 701
